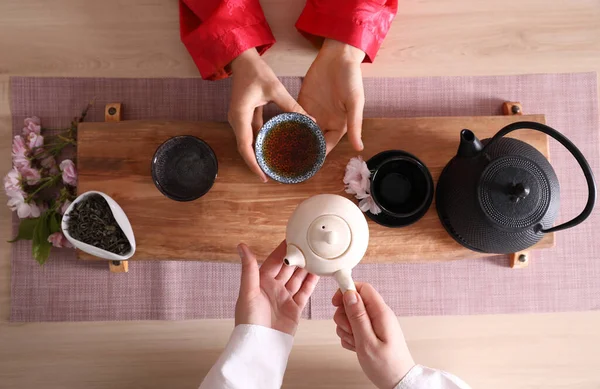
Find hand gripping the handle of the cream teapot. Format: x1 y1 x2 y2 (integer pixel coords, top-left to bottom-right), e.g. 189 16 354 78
332 283 415 389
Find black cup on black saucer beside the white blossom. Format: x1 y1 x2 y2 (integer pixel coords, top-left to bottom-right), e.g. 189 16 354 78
367 150 433 227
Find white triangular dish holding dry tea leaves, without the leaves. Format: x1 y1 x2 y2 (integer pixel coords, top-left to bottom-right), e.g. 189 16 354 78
60 191 135 261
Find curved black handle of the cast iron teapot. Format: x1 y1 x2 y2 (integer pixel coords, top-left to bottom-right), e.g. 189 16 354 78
481 122 596 233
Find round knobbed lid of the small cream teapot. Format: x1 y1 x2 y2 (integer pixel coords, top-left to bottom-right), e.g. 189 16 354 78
307 215 352 259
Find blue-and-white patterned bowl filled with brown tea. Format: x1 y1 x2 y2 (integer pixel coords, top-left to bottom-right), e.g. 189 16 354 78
254 112 327 184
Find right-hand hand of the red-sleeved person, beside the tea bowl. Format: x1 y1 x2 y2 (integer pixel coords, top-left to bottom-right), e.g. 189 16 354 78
298 39 365 153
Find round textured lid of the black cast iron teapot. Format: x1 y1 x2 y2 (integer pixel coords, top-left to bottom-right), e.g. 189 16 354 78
478 155 551 230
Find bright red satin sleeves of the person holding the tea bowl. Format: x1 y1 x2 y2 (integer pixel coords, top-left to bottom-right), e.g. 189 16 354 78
179 0 398 80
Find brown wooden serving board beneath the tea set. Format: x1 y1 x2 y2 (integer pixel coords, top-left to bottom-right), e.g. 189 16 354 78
77 115 554 263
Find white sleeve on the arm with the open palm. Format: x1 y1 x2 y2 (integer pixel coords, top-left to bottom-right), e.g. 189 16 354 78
200 324 294 389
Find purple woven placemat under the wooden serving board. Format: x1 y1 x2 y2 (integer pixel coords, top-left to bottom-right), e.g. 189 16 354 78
11 73 600 321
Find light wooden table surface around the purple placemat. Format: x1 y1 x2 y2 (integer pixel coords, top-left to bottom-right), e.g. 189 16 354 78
0 0 600 389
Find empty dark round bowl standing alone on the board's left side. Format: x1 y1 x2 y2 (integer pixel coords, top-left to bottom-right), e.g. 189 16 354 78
152 135 218 201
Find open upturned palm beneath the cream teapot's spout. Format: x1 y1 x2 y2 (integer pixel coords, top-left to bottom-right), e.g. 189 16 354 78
235 241 319 336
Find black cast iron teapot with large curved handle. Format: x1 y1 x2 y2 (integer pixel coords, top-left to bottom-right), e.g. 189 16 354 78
436 122 596 254
